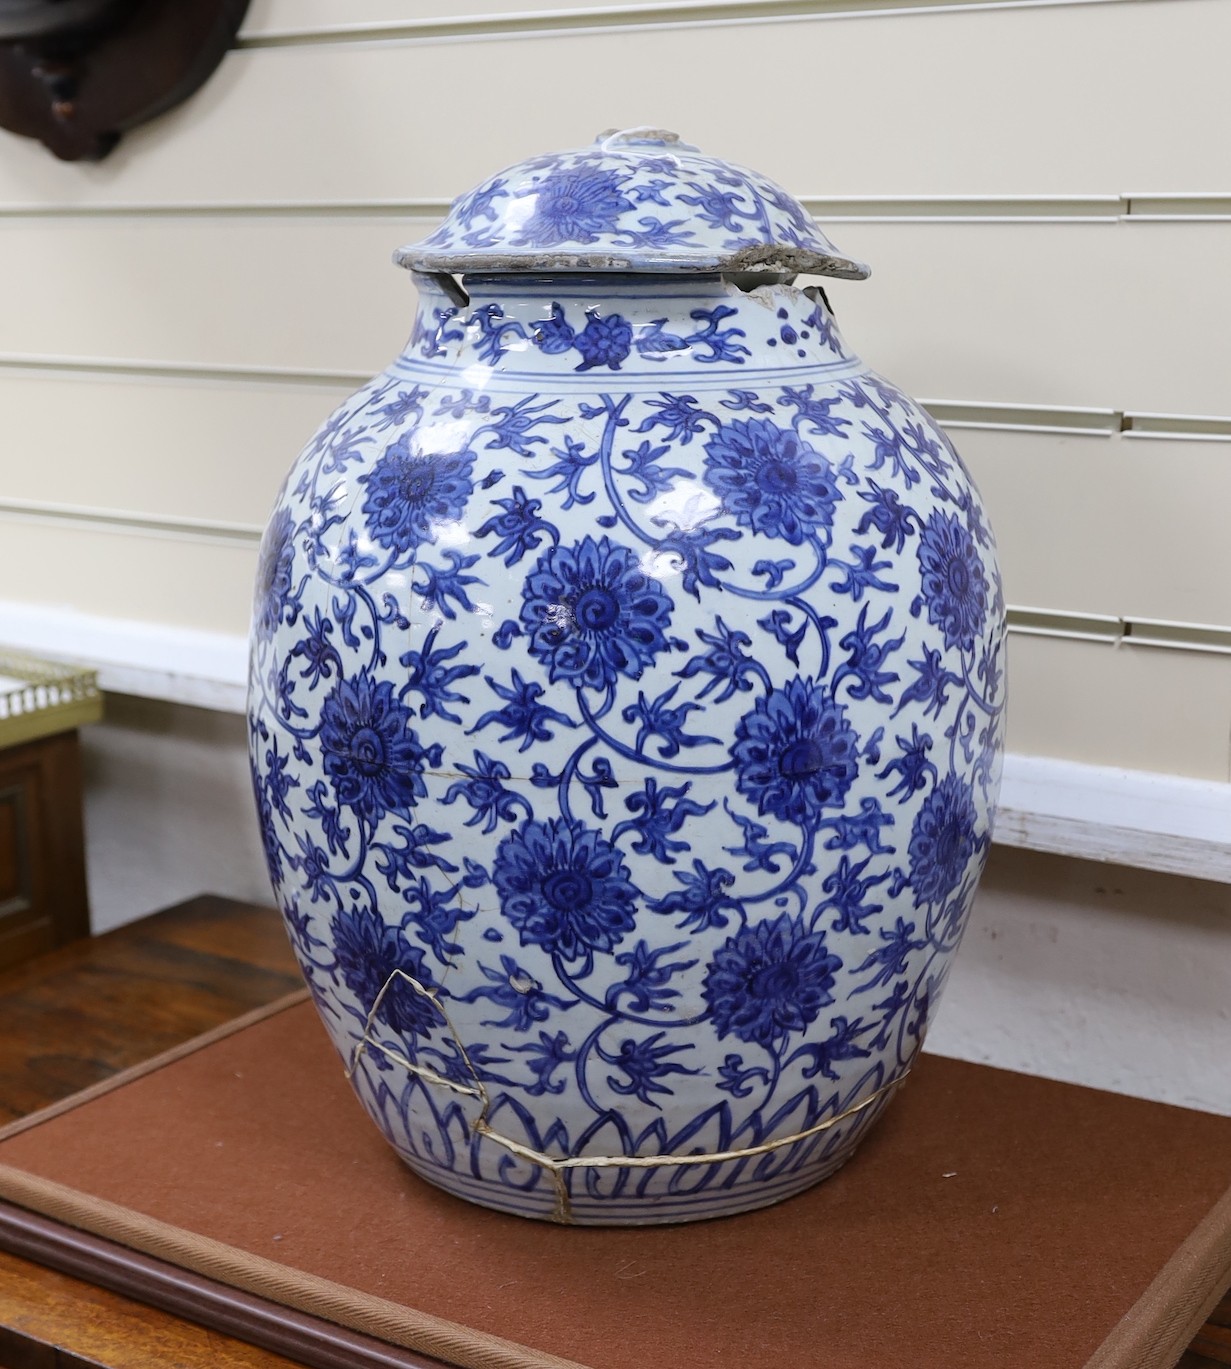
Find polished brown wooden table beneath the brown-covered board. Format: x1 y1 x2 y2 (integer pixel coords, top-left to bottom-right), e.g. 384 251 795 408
0 895 1231 1369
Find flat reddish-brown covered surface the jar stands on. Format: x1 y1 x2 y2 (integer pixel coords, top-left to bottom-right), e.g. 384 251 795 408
0 1003 1231 1369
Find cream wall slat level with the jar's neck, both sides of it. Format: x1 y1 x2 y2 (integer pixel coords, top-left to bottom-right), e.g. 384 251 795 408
0 216 1231 416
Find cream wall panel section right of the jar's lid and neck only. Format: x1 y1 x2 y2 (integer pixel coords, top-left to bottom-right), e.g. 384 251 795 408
830 220 1231 415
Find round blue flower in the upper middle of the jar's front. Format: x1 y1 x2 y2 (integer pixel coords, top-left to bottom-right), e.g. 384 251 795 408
522 537 672 689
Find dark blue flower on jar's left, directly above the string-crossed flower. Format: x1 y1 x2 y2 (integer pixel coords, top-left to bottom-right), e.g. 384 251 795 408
320 669 441 823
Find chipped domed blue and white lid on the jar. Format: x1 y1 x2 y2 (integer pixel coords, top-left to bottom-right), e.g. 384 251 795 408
393 129 868 281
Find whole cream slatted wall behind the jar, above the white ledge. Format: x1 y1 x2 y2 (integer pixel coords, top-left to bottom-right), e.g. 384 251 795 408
0 0 1231 799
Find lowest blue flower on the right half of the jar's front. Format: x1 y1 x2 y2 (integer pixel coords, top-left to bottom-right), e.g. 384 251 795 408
702 913 842 1049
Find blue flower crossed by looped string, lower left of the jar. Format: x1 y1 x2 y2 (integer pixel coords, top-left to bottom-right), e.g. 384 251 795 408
331 908 441 1036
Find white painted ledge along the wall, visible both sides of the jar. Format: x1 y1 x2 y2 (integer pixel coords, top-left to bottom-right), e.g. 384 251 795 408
0 602 1231 883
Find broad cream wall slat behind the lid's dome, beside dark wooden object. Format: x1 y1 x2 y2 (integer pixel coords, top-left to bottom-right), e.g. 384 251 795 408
0 0 1231 204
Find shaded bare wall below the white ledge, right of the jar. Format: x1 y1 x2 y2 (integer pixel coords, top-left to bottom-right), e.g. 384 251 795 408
927 846 1231 1114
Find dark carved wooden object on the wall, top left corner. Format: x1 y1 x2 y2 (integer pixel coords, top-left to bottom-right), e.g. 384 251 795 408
0 0 248 162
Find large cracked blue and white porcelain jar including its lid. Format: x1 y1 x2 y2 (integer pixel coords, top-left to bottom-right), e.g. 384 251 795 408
251 129 1004 1223
